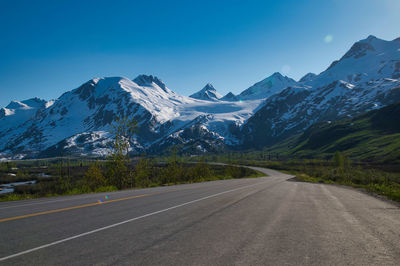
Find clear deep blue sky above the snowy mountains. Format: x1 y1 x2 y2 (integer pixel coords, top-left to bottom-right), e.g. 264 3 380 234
0 0 400 107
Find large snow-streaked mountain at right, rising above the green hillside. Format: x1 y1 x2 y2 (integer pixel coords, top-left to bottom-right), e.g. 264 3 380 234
241 36 400 147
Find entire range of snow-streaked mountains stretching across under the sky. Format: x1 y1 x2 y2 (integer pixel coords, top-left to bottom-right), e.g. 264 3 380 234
0 36 400 159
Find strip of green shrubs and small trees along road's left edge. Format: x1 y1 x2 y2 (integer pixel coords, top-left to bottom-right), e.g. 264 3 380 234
8 158 261 196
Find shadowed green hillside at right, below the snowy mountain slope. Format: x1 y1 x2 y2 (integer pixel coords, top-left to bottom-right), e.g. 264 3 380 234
271 103 400 163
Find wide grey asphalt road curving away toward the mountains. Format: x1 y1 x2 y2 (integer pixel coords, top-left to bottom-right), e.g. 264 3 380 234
0 168 400 265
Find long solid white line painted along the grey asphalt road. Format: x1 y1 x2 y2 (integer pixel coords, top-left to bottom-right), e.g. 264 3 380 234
0 181 268 261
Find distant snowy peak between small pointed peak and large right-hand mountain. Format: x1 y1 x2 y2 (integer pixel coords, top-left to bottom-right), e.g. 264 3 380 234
237 72 297 100
